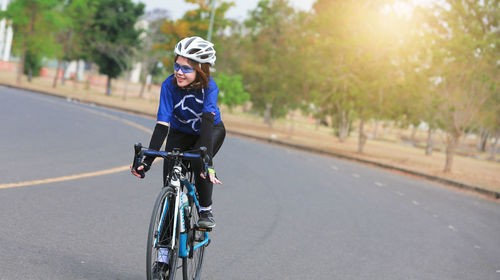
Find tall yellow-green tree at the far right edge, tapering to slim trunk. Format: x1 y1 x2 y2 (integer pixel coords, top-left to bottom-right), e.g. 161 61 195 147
420 0 500 172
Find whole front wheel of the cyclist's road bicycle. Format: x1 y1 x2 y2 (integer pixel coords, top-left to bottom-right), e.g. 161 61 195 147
146 187 179 280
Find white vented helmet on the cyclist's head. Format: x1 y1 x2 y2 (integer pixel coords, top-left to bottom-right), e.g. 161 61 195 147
174 36 216 67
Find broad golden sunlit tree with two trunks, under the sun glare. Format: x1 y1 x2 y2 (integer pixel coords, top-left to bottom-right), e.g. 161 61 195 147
307 0 408 153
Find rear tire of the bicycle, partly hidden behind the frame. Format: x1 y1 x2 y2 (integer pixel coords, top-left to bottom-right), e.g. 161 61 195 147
182 203 206 280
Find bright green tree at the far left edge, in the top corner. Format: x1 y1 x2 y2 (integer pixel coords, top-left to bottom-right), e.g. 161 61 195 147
0 0 62 84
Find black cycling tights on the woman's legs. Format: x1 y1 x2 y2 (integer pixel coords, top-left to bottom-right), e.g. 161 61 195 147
163 122 226 207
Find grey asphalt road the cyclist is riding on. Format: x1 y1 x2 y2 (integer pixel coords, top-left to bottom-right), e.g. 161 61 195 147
0 86 500 280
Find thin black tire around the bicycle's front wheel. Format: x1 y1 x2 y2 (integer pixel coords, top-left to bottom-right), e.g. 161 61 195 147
146 187 179 280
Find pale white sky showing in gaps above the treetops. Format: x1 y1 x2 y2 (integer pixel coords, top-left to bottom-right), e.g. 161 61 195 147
133 0 315 20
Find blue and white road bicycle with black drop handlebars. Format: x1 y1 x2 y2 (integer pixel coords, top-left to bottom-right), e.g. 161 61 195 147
133 143 211 280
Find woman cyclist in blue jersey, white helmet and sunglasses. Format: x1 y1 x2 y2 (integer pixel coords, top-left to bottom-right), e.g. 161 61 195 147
131 37 226 228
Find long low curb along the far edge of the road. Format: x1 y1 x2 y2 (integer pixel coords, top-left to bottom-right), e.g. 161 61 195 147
0 83 500 200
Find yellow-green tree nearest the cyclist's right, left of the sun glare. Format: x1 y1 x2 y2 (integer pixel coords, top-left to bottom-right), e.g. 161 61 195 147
240 0 301 126
